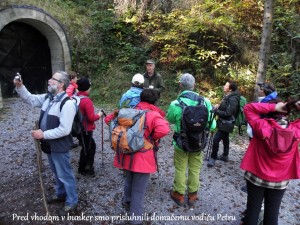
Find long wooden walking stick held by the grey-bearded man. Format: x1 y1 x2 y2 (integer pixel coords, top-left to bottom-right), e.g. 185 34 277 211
34 121 53 224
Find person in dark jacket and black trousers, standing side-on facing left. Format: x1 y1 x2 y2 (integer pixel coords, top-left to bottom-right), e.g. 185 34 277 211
207 81 240 167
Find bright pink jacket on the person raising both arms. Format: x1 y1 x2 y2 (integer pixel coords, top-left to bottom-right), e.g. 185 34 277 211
241 103 300 182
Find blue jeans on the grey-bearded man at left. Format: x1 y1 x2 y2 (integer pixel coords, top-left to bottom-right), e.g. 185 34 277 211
47 152 78 207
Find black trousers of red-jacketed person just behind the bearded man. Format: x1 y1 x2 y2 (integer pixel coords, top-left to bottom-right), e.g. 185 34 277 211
78 131 96 170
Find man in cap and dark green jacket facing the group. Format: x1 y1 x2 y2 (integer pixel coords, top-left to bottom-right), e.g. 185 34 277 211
144 59 166 96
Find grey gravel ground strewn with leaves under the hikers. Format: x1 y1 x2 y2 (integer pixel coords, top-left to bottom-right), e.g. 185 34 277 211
0 98 300 225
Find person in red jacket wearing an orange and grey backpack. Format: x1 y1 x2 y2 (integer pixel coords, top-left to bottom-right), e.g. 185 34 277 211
105 89 170 224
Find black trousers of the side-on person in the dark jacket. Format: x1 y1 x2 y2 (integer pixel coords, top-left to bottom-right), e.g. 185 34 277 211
211 130 229 159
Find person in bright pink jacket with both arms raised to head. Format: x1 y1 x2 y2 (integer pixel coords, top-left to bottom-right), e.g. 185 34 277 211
241 100 300 225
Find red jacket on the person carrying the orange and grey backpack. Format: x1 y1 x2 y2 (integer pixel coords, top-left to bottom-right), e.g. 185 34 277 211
105 102 170 173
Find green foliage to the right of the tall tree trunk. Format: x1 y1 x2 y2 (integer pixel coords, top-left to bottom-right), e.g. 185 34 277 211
267 1 300 99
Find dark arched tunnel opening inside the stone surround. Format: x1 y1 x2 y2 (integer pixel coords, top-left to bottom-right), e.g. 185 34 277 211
0 22 52 98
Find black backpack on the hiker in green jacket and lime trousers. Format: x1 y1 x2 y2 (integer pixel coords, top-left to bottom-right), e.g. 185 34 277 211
174 92 208 152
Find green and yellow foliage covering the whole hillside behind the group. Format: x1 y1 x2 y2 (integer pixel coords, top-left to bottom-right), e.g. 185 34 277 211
0 0 300 109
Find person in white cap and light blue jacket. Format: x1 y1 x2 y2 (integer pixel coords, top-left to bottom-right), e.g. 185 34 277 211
119 73 144 108
